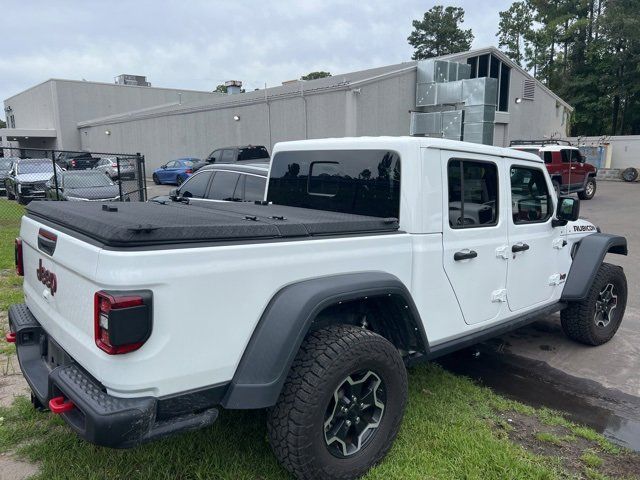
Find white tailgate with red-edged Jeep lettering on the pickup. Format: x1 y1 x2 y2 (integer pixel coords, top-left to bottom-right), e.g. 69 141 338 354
20 216 100 370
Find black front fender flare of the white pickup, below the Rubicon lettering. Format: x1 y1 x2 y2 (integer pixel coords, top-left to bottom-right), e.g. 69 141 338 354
560 233 628 302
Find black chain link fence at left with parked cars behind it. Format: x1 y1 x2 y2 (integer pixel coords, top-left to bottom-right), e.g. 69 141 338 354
0 147 147 216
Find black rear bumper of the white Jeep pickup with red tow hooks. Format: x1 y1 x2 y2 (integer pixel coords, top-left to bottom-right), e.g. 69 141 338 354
9 304 218 448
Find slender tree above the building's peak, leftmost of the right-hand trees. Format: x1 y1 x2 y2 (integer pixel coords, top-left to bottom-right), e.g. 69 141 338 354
496 1 535 66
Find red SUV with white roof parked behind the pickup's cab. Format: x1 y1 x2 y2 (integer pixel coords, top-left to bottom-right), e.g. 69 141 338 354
511 140 598 200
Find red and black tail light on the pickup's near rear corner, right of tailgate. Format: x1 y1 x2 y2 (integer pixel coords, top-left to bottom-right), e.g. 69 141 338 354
94 290 152 355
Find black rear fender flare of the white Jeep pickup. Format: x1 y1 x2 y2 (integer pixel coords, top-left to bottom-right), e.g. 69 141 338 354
221 271 428 409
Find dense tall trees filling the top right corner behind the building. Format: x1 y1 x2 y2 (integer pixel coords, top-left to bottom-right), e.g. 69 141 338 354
497 0 640 135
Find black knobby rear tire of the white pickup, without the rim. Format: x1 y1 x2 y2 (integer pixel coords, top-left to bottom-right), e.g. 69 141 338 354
267 325 407 480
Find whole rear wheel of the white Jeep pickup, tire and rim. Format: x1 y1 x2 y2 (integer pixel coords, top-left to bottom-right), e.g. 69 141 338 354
267 325 407 479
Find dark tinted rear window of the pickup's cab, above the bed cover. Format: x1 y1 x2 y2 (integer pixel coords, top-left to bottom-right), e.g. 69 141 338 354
267 150 400 218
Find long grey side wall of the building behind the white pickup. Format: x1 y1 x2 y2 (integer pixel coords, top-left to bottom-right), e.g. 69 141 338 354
80 72 415 171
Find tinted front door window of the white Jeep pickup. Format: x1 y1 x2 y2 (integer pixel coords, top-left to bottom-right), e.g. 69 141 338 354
511 166 553 224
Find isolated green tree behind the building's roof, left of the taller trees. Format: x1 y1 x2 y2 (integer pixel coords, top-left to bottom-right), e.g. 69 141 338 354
407 5 473 60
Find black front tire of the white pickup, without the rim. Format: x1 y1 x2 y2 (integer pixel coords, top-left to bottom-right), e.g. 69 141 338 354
560 263 627 345
